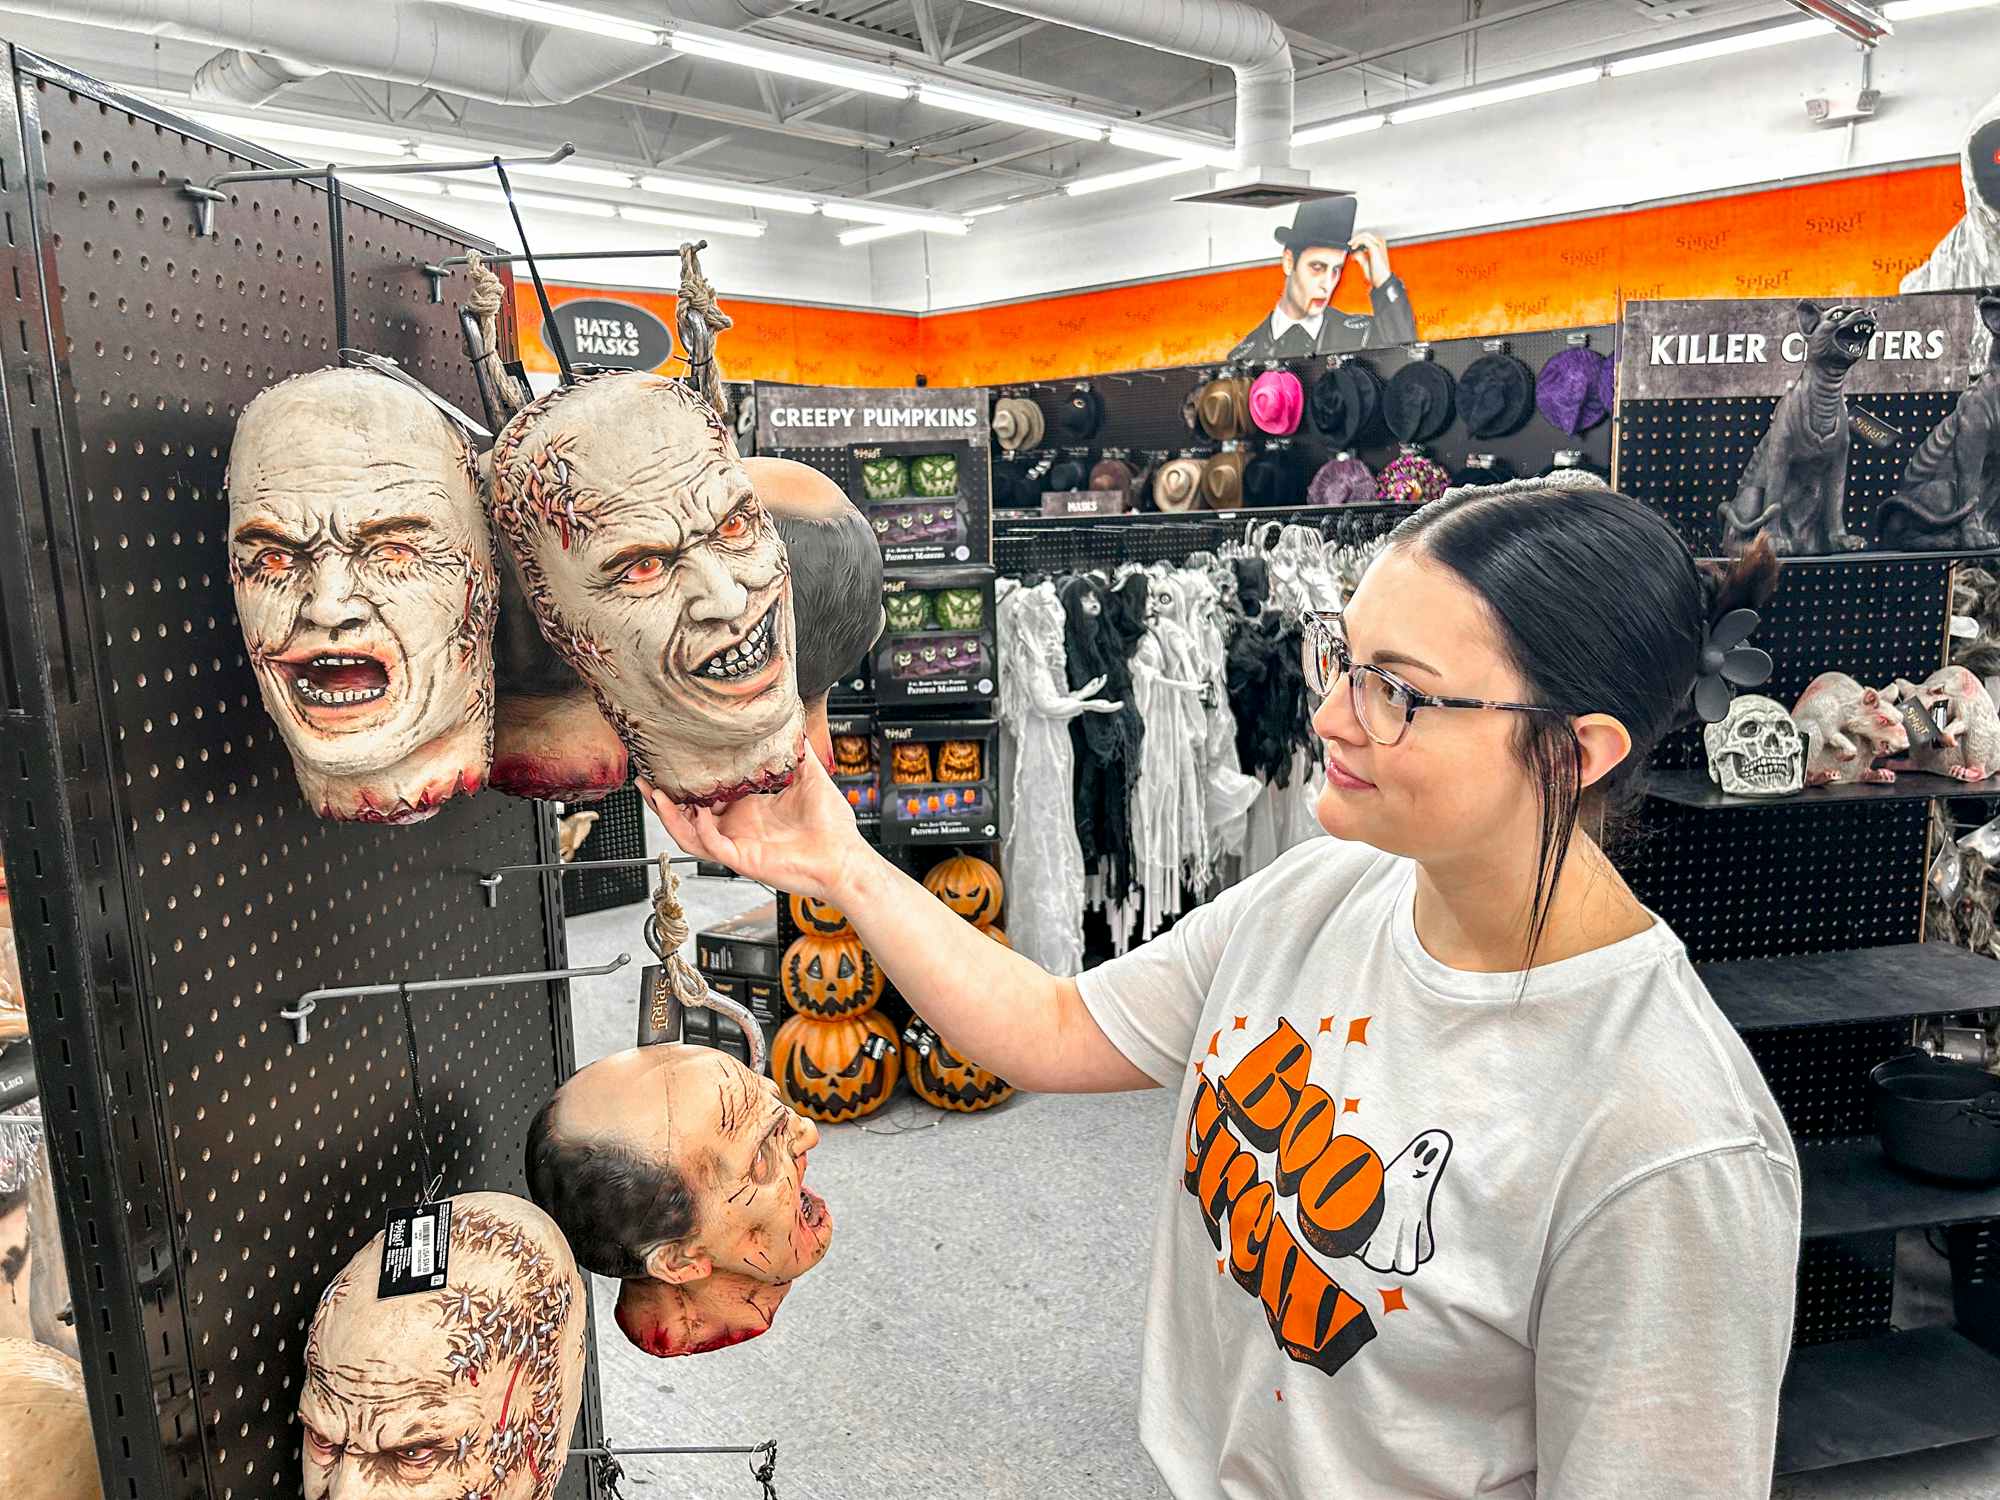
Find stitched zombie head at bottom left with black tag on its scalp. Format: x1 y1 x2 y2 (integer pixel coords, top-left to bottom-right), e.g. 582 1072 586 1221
298 1192 590 1500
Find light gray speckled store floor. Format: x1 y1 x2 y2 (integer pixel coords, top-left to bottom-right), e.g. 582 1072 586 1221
570 836 2000 1500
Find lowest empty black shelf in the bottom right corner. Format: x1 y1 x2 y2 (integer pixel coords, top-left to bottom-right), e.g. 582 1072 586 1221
1778 1328 2000 1474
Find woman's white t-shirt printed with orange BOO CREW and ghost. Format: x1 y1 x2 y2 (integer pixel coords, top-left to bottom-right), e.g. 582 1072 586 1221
1078 838 1800 1500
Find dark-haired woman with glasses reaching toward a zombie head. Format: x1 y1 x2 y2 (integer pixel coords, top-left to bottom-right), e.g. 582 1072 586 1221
648 490 1800 1500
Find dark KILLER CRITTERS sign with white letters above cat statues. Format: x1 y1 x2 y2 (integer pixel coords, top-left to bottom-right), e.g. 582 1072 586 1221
1618 292 1976 400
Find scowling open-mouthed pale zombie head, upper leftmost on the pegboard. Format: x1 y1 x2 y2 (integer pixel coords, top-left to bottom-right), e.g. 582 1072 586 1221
228 370 496 822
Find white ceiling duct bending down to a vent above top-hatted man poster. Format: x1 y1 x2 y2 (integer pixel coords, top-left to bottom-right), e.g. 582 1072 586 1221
988 0 1326 208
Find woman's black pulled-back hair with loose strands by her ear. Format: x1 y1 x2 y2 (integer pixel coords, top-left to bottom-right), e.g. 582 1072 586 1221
1388 486 1778 968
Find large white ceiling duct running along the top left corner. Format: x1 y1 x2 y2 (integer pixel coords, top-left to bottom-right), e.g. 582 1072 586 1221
0 0 798 104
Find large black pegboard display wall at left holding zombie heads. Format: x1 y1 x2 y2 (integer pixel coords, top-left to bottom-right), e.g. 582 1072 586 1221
0 56 596 1500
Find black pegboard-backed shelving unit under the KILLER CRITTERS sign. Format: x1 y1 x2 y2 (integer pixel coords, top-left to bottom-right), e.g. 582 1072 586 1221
1616 296 2000 1474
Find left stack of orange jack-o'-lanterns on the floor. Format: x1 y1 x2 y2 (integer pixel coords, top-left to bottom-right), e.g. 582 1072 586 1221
770 896 902 1124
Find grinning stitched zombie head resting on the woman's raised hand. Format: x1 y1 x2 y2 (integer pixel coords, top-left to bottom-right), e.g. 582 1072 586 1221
492 370 804 804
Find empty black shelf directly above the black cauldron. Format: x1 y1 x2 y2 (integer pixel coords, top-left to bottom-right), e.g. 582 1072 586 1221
1698 942 2000 1032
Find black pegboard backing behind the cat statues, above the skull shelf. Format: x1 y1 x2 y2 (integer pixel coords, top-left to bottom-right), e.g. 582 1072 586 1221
1616 392 1958 556
